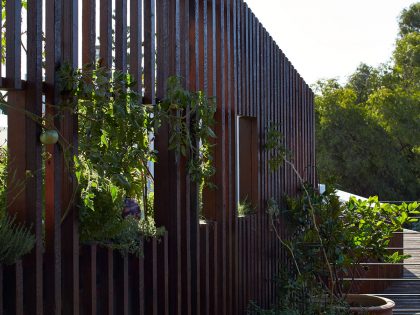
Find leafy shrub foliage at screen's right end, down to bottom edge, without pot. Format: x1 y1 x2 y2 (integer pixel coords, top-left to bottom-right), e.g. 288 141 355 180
260 185 420 315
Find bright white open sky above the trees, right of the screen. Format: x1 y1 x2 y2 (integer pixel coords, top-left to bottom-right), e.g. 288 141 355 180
245 0 418 84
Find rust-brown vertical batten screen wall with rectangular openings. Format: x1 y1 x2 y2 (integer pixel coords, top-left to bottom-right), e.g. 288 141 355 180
0 0 316 315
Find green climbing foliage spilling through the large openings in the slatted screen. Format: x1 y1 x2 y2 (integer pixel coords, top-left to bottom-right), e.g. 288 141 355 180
58 64 215 254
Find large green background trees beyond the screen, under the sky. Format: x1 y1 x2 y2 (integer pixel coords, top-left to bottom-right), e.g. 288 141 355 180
315 3 420 200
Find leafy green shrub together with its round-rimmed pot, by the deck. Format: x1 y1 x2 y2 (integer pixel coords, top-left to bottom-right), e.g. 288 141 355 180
268 185 420 314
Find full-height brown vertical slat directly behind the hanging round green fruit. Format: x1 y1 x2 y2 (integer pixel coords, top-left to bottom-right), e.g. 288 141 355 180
45 0 62 314
